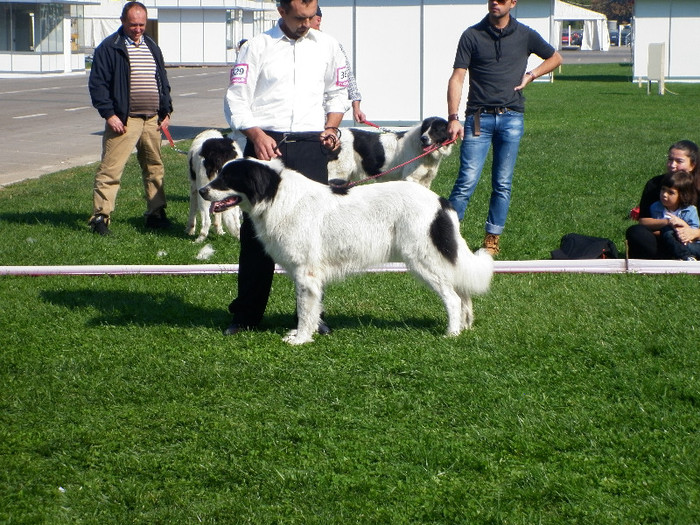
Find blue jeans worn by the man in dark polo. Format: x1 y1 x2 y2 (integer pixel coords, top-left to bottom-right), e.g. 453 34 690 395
449 111 525 235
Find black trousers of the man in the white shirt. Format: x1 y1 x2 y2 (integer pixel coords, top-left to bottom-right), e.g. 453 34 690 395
228 131 328 326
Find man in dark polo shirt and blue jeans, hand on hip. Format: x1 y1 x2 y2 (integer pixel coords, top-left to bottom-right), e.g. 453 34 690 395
447 0 562 256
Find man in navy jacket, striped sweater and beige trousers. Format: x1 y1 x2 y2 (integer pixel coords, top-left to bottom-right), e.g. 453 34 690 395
88 2 173 235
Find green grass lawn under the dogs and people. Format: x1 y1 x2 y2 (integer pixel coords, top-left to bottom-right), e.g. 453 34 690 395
0 64 700 524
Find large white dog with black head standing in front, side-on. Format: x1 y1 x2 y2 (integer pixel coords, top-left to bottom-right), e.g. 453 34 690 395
200 158 493 345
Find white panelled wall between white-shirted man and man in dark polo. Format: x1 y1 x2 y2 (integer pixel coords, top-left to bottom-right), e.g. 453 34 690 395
321 0 556 124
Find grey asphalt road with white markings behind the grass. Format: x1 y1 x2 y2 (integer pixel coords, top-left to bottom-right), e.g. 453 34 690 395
0 47 632 186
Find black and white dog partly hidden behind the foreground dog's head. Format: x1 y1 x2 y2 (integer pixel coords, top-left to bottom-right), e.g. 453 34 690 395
185 129 243 242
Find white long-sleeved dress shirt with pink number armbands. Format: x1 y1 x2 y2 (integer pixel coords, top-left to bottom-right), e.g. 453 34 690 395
224 22 350 132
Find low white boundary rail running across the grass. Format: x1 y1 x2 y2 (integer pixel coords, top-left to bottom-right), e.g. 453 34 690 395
0 259 700 276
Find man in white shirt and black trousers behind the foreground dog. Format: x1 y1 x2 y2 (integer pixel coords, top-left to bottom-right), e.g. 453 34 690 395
224 0 349 335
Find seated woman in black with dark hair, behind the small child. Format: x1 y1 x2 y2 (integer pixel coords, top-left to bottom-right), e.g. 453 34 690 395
626 140 700 259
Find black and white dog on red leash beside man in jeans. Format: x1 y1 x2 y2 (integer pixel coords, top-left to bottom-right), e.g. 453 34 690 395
328 117 452 188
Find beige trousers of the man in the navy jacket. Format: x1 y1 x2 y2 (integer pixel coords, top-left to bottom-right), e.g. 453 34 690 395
90 115 165 222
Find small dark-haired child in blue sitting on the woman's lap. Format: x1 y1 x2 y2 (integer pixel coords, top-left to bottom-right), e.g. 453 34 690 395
639 171 700 261
